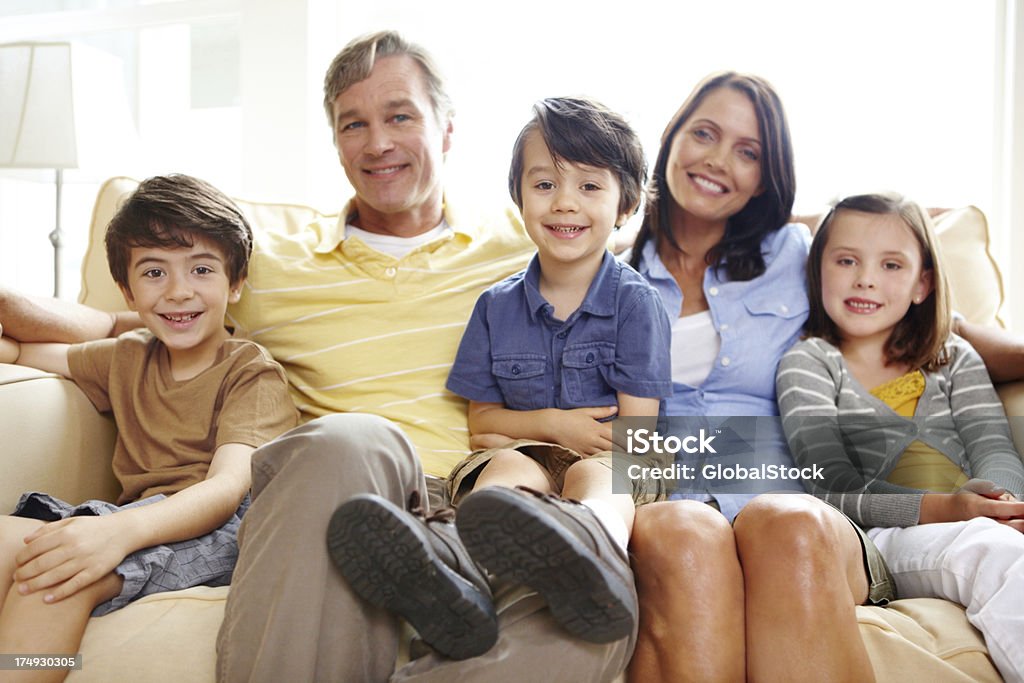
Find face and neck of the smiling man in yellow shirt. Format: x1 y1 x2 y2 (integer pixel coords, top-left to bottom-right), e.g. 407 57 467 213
334 55 452 237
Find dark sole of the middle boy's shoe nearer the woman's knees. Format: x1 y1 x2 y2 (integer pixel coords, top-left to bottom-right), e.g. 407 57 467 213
457 487 637 643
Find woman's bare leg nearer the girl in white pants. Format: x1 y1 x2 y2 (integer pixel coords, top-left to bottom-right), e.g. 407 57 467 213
734 495 874 682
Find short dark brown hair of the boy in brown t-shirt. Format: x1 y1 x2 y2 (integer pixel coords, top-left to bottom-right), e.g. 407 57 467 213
103 174 253 289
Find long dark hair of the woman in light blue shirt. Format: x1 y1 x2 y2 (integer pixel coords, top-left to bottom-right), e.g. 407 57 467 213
630 71 797 281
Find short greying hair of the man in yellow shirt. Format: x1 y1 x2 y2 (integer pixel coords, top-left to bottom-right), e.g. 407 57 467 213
324 31 455 131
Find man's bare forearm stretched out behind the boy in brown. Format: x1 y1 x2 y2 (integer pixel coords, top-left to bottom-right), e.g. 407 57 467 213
0 287 142 344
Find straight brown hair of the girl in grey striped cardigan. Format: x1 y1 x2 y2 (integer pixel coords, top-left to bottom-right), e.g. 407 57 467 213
804 193 952 372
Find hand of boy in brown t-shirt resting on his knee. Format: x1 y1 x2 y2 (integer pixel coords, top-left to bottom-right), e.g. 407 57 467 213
14 514 127 602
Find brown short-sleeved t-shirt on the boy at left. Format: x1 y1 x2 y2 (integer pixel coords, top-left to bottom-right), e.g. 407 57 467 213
68 330 297 505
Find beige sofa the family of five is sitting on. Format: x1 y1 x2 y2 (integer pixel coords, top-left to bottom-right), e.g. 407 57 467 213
0 178 1024 683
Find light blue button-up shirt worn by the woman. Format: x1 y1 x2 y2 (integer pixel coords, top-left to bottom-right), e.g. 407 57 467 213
626 223 811 519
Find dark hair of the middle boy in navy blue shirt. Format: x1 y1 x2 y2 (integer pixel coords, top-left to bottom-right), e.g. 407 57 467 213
509 97 647 219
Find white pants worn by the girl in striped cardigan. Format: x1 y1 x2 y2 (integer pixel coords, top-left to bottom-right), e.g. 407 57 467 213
867 517 1024 683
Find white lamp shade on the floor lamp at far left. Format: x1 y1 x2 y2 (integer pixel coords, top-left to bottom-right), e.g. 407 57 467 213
0 43 78 168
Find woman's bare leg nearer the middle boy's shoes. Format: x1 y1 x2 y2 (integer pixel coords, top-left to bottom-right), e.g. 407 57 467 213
629 501 745 683
